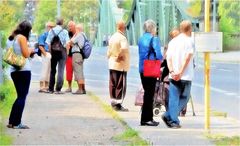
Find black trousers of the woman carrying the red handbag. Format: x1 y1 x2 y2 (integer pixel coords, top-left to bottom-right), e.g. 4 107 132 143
140 73 157 122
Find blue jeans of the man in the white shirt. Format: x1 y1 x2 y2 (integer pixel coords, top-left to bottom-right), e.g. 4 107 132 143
164 79 192 124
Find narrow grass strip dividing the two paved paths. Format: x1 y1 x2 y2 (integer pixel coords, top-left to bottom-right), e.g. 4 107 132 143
88 92 150 146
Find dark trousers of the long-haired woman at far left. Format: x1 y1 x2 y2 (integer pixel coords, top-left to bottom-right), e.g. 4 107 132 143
9 71 31 126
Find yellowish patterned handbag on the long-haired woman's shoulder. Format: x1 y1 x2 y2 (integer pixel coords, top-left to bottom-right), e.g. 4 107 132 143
3 40 26 69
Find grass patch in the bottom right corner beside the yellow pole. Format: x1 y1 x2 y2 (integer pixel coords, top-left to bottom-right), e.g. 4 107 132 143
207 135 240 146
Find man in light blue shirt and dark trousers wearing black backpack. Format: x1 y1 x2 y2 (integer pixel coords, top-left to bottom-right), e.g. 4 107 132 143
46 18 69 94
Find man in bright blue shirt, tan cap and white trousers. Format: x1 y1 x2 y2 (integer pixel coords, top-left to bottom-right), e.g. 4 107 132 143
38 22 54 92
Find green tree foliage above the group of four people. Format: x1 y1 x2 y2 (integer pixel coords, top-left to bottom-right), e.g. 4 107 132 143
34 0 98 39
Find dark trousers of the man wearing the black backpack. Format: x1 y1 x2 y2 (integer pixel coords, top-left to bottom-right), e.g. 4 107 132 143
49 51 67 91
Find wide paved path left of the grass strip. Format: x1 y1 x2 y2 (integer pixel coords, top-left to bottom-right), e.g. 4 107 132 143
5 82 128 145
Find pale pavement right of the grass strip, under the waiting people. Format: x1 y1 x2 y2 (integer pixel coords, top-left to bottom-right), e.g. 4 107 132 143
88 84 240 145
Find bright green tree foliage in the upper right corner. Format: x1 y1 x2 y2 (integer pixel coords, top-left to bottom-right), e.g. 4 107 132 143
218 0 240 49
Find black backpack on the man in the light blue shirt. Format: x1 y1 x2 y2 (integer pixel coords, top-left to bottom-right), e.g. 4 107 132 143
51 29 64 51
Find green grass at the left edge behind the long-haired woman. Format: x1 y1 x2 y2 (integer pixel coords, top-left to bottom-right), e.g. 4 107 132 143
0 81 16 145
